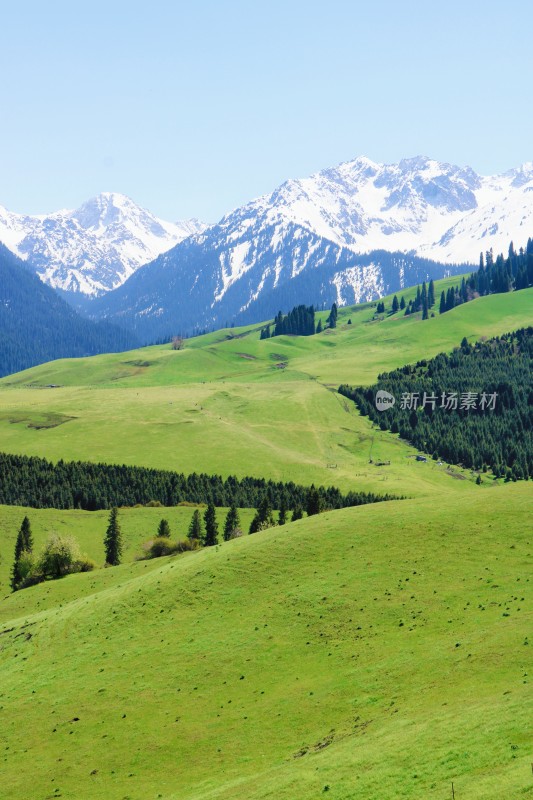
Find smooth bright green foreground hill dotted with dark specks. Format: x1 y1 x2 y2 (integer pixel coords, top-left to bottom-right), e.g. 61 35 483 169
0 484 533 800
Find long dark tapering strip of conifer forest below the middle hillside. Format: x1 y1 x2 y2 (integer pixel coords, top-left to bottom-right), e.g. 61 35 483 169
0 453 394 511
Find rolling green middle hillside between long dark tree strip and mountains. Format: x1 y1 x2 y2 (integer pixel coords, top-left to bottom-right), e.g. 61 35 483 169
0 289 533 494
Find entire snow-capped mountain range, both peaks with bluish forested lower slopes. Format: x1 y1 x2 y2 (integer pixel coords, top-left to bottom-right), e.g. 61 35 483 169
0 157 533 341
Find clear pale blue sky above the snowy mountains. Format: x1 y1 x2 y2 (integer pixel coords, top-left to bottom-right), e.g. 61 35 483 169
0 0 533 222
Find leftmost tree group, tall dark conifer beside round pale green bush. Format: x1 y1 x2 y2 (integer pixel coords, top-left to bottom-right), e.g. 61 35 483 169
11 517 96 592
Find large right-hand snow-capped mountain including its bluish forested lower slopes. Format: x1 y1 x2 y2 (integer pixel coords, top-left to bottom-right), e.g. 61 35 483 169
89 157 533 338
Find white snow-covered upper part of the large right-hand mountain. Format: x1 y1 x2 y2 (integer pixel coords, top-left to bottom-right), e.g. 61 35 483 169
244 156 533 263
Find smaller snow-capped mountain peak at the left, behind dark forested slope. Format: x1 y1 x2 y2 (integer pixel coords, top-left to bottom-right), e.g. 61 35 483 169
0 192 205 295
